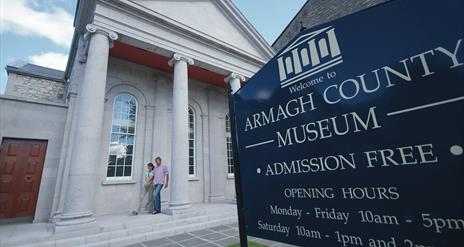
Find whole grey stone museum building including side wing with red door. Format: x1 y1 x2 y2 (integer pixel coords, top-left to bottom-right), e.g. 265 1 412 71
0 0 274 231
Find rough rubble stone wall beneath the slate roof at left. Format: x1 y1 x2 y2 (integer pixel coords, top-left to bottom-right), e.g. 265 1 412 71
5 72 66 103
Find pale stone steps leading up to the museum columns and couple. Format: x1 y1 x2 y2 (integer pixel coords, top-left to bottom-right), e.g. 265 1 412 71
0 204 237 247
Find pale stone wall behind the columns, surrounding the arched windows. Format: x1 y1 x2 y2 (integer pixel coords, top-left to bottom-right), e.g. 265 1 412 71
94 57 235 215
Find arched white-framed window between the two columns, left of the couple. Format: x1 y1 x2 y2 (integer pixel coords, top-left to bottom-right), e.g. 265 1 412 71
106 93 137 179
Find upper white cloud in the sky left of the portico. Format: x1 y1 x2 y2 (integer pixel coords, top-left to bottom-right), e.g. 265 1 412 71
0 0 73 48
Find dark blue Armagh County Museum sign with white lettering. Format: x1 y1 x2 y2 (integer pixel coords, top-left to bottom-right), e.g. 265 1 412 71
234 0 464 247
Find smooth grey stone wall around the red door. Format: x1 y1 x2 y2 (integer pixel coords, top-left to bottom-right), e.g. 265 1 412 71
0 96 68 222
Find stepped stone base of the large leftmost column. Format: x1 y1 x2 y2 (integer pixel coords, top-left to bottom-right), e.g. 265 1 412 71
54 212 99 233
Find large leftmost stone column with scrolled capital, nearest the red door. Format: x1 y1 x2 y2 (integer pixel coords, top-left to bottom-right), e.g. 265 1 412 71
55 24 118 231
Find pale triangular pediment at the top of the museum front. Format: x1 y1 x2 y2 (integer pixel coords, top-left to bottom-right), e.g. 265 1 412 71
129 0 273 61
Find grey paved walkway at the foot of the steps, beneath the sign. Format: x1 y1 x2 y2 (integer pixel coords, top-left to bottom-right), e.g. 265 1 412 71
127 223 292 247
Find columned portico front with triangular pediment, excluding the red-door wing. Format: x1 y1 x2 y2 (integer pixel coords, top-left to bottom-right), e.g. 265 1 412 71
44 0 273 232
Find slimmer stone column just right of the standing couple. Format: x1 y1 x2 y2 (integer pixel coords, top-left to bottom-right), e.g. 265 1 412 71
167 53 193 214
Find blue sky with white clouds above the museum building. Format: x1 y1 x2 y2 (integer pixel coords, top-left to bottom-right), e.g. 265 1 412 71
0 0 306 94
